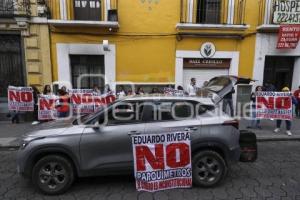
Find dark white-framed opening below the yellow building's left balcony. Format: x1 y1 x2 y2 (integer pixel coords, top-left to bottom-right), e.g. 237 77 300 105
70 55 104 91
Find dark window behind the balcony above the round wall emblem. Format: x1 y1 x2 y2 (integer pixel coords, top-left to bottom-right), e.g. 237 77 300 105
196 0 222 24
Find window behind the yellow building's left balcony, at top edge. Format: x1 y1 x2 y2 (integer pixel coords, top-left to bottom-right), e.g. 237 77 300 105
74 0 102 21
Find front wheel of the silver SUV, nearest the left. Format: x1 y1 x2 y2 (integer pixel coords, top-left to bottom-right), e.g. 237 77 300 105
32 155 75 195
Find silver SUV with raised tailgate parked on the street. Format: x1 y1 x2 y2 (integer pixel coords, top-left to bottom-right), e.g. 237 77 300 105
17 76 256 194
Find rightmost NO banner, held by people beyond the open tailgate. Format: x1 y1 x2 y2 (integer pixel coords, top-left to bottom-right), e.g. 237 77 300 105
256 92 293 120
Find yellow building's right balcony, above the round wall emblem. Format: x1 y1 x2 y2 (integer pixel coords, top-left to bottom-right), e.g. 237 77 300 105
176 0 249 31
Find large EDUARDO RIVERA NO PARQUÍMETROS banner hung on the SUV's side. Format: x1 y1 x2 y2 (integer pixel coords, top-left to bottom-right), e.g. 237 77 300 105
132 132 192 192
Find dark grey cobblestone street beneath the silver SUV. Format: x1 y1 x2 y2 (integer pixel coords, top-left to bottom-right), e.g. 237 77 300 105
0 142 300 200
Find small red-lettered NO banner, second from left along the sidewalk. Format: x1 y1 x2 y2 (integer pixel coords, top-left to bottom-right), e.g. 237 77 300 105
38 95 58 120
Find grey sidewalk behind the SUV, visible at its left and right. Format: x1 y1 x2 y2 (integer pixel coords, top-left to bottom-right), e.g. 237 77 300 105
0 119 300 148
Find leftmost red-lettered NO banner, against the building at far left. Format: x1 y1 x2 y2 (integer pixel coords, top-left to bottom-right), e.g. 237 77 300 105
7 86 34 111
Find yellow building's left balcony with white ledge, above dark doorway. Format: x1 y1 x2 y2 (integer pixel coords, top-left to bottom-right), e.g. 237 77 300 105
46 0 119 30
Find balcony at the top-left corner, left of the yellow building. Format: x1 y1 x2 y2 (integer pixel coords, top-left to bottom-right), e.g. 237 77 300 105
0 0 31 18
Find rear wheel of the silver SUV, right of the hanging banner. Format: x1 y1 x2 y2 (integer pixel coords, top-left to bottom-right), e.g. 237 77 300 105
192 150 228 187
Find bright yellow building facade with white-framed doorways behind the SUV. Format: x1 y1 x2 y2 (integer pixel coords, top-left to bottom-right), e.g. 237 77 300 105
48 0 272 93
